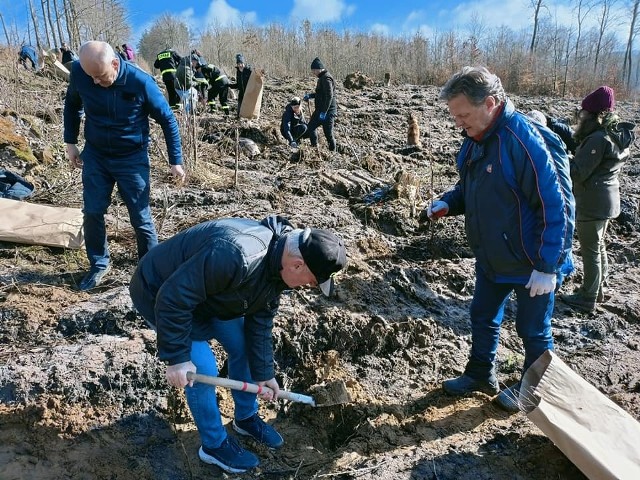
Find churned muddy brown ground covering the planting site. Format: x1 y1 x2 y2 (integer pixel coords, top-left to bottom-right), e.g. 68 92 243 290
0 54 640 480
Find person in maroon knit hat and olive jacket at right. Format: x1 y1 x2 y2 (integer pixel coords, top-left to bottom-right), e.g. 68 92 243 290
560 86 635 312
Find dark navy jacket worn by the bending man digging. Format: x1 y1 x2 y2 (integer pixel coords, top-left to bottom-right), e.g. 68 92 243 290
129 216 293 381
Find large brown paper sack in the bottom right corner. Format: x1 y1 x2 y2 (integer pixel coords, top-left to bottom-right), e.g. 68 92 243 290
520 350 640 480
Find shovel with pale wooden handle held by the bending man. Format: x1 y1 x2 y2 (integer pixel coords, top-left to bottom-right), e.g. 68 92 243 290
187 372 351 407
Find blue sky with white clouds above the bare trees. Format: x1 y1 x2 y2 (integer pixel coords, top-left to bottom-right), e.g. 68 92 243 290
0 0 629 42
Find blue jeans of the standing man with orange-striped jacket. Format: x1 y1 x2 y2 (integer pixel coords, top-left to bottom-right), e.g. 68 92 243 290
465 268 555 380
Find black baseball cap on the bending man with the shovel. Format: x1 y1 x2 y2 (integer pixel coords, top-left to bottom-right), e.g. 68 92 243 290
299 228 347 297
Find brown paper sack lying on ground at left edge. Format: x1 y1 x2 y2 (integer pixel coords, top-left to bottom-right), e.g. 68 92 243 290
0 198 84 248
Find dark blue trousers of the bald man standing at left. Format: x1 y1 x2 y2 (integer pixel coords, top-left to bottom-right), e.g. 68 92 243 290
82 152 158 270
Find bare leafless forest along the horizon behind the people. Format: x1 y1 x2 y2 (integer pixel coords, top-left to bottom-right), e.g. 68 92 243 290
0 0 640 100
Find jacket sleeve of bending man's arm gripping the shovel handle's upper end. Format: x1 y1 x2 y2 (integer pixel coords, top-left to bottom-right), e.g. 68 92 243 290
154 246 244 365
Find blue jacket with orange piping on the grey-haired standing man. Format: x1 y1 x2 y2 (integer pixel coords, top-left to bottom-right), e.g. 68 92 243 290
442 100 575 283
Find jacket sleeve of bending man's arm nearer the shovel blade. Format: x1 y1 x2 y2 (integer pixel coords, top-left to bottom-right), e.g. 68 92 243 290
244 298 280 382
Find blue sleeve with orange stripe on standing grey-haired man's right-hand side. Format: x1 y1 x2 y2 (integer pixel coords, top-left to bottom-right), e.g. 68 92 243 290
511 130 573 273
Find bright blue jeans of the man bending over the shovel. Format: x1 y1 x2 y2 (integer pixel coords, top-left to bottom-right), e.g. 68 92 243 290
185 317 258 448
